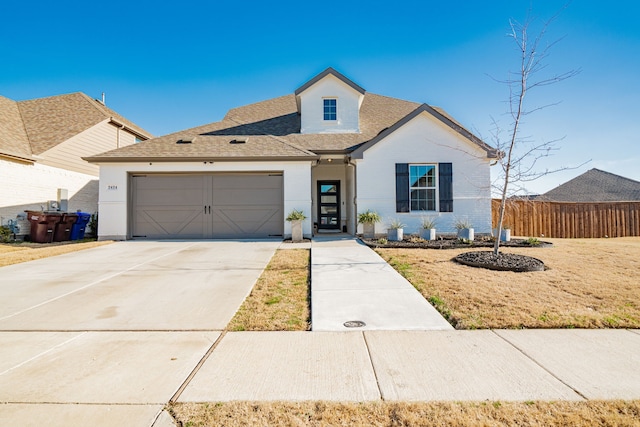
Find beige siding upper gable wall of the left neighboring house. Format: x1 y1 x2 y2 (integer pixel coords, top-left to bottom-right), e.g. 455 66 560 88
38 120 135 177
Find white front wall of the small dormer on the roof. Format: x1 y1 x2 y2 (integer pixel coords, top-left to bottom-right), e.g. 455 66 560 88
300 75 364 133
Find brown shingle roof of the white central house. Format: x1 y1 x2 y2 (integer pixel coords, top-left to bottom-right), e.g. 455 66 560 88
85 68 497 163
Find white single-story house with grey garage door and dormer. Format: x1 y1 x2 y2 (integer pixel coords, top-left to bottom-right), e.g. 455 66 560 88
85 68 498 239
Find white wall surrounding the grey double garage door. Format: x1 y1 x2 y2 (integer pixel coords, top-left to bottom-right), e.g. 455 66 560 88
98 161 312 240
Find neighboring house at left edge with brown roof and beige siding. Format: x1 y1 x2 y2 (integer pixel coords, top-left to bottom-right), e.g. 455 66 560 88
0 92 152 234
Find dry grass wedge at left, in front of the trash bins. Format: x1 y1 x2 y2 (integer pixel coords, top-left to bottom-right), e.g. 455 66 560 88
0 241 112 267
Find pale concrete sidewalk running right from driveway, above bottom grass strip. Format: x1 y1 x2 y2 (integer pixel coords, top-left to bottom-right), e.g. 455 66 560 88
177 330 640 402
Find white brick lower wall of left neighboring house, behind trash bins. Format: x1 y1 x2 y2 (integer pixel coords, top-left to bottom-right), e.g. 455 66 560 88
0 158 98 231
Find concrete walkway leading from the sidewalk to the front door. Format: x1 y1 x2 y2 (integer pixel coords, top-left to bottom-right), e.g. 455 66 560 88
311 236 453 331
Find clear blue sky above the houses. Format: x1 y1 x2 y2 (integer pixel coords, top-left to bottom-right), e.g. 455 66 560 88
0 0 640 193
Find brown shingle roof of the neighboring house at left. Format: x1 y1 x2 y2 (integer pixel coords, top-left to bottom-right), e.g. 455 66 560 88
0 92 152 159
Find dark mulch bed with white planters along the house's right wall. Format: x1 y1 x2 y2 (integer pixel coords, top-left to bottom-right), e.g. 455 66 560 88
360 236 552 249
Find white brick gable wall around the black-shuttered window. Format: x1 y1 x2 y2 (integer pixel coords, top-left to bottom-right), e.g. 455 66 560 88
356 113 491 234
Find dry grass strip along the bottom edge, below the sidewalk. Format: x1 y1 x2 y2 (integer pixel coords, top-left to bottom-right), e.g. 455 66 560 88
169 400 640 427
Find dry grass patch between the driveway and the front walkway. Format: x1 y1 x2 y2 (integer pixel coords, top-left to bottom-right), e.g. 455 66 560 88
227 249 311 331
